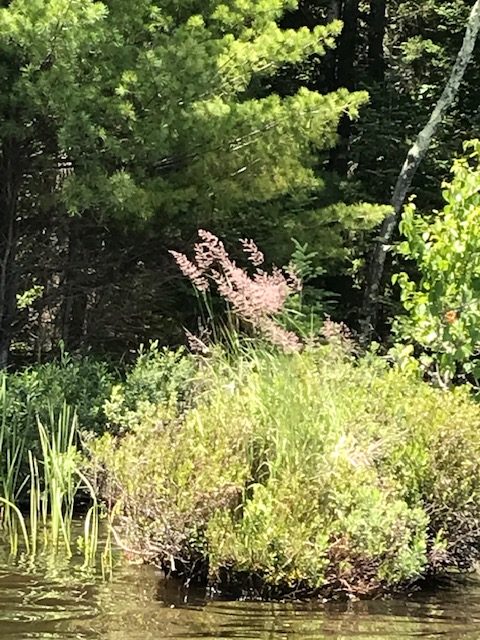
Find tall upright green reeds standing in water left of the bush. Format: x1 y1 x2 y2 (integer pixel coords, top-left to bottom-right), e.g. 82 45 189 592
0 400 105 568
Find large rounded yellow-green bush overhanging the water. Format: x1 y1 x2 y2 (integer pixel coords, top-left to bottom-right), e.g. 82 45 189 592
91 346 480 596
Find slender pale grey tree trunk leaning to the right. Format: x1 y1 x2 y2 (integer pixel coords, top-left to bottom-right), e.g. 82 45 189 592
362 0 480 339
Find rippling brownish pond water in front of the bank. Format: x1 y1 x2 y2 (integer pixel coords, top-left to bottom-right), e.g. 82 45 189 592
0 536 480 640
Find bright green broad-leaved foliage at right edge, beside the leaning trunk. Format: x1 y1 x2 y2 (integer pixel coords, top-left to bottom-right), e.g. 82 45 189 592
394 140 480 384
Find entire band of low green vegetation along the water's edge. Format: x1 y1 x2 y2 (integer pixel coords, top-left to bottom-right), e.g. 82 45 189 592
0 338 480 598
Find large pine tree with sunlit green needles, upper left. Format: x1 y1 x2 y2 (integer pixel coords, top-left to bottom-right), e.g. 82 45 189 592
0 0 367 366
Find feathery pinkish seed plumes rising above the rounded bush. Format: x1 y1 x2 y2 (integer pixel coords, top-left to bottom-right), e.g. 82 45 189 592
170 229 302 351
